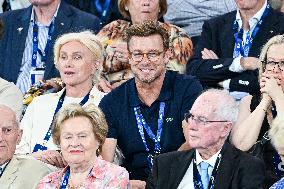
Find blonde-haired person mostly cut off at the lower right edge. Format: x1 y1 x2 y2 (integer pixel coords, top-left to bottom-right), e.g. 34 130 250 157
269 113 284 189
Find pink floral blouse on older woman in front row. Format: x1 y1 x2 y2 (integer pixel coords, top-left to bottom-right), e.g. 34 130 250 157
36 157 130 189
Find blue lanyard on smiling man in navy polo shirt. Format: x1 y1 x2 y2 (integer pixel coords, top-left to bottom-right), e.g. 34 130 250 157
134 102 165 168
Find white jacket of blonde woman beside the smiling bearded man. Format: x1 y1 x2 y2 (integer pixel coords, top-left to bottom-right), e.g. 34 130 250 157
16 86 105 154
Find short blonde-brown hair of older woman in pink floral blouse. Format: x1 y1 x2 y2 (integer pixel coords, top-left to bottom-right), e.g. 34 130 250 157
51 103 108 156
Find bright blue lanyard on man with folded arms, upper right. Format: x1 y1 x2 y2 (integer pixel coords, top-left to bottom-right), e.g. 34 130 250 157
233 4 270 58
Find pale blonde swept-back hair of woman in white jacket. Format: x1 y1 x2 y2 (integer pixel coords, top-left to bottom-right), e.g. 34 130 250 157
54 30 104 83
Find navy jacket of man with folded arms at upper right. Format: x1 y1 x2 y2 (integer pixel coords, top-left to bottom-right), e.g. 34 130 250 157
186 9 284 94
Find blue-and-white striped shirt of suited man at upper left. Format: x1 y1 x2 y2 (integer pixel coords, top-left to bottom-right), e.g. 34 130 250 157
16 5 59 93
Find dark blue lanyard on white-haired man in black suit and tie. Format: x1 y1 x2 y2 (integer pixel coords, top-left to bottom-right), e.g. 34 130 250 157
193 152 223 189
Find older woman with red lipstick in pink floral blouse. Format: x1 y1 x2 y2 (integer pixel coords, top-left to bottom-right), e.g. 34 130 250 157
37 104 129 189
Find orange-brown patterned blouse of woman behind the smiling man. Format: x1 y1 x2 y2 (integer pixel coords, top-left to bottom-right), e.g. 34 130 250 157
97 20 193 86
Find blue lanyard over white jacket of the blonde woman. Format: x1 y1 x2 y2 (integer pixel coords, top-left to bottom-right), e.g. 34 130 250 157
33 90 90 152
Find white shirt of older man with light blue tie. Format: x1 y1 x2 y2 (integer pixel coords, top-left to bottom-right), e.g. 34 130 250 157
178 149 221 189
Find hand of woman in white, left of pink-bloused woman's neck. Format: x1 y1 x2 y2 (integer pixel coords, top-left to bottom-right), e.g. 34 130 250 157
31 150 67 168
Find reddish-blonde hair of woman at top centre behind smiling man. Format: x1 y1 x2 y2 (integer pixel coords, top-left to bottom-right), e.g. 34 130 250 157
118 0 168 19
